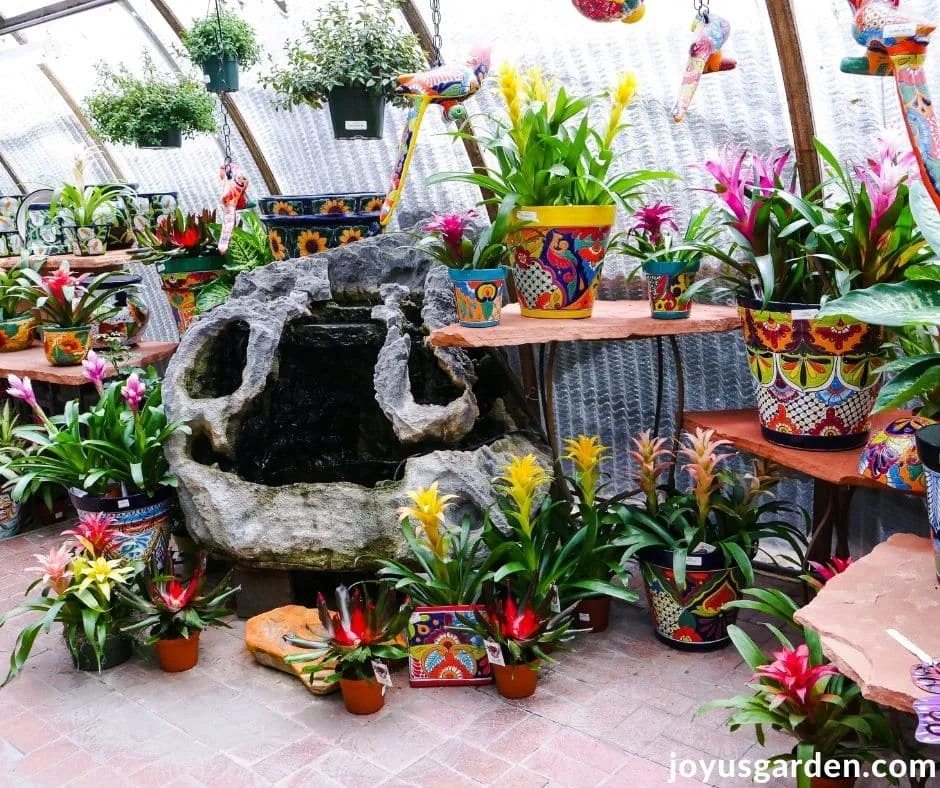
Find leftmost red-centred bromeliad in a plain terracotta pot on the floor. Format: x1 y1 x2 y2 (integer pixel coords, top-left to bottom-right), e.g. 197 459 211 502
120 552 239 673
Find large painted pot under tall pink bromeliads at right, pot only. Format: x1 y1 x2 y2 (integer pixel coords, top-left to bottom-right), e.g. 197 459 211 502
738 299 885 451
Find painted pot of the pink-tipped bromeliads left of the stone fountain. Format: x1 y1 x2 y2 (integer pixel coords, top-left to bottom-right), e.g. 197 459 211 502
69 487 173 569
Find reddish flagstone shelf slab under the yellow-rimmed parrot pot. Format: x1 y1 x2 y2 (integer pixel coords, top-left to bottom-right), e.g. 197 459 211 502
430 301 741 348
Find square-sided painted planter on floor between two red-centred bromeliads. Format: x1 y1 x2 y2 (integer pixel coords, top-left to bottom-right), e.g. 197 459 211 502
408 605 493 687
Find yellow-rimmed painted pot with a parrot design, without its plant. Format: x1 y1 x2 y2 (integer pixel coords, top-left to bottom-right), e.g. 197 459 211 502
509 205 617 318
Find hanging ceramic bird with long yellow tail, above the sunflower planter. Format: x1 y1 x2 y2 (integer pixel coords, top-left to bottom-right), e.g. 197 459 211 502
379 47 490 227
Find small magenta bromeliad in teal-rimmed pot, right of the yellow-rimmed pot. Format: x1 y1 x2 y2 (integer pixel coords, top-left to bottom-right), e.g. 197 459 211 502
616 202 721 320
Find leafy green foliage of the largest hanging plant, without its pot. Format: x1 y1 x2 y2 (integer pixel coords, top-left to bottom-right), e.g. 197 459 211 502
261 0 427 109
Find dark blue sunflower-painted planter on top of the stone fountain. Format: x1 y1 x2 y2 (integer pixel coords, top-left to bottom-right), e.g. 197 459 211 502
258 193 385 260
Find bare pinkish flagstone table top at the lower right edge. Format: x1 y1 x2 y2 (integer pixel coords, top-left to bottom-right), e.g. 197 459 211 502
796 534 940 712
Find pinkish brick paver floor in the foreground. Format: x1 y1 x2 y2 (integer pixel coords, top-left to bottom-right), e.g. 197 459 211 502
0 529 916 788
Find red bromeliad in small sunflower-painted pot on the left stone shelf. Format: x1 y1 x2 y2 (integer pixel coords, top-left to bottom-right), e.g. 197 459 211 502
13 262 117 367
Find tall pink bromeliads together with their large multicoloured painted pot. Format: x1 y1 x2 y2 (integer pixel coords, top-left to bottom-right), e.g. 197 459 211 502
705 140 930 450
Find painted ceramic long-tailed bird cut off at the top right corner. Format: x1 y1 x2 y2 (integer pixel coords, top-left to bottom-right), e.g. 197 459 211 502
841 0 940 210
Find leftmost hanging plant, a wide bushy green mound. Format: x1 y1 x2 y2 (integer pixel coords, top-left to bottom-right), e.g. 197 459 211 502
86 57 216 148
